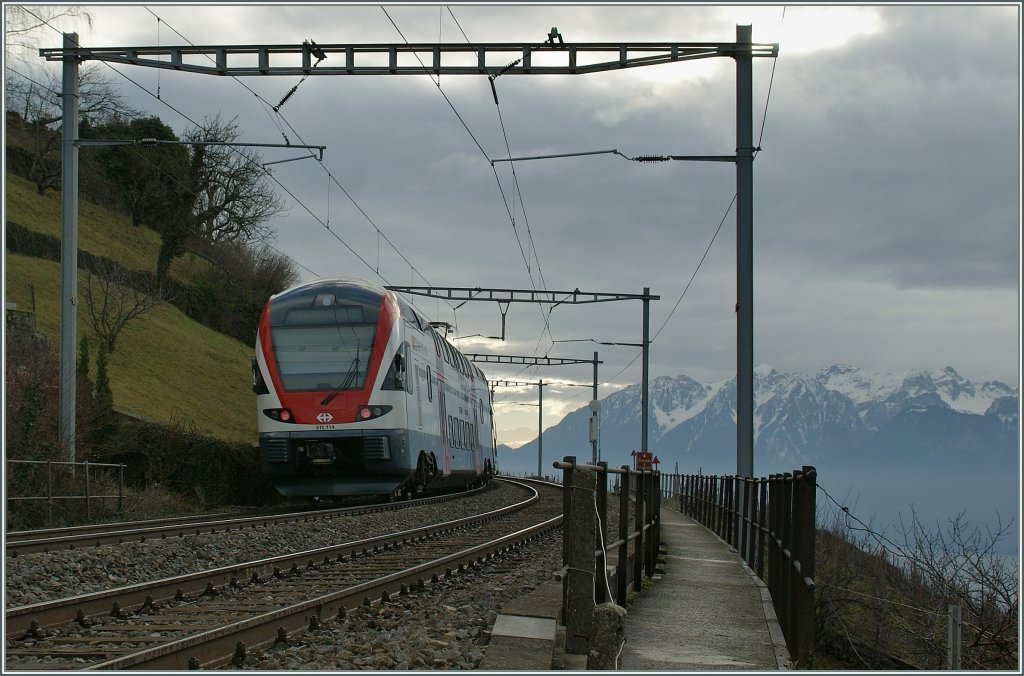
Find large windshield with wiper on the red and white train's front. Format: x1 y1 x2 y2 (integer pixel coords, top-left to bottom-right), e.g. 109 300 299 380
270 294 380 392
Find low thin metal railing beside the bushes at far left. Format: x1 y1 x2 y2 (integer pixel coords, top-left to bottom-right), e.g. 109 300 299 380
5 460 125 527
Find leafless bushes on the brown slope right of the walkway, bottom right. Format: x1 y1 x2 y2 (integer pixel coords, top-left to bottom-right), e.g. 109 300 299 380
815 501 1020 670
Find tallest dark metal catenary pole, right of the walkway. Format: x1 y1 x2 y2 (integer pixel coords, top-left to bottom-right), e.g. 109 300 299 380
736 26 754 477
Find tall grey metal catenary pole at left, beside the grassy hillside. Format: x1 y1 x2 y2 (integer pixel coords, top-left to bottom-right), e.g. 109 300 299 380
60 33 78 462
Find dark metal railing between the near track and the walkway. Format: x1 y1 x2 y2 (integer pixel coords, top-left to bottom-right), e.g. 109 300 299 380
554 456 662 654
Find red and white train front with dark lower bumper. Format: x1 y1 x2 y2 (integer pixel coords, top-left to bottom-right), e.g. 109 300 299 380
253 280 411 499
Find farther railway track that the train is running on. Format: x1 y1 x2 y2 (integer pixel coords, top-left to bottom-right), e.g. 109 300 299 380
4 489 483 557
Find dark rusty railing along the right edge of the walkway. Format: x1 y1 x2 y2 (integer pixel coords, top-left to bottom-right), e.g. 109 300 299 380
660 466 817 666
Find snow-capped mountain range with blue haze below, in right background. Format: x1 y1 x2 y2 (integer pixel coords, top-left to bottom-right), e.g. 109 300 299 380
498 365 1020 522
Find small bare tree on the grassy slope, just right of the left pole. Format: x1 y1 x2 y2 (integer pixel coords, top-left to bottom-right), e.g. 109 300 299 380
82 263 161 353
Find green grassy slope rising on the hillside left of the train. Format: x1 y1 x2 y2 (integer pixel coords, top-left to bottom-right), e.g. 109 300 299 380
4 173 256 441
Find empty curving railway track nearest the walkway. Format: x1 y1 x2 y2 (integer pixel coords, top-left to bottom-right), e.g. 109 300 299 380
5 482 561 670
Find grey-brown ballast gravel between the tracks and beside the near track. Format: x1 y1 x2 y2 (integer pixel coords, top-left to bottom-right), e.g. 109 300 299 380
5 482 616 671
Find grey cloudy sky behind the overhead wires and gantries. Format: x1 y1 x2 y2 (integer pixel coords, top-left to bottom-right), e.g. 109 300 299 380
4 3 1021 446
